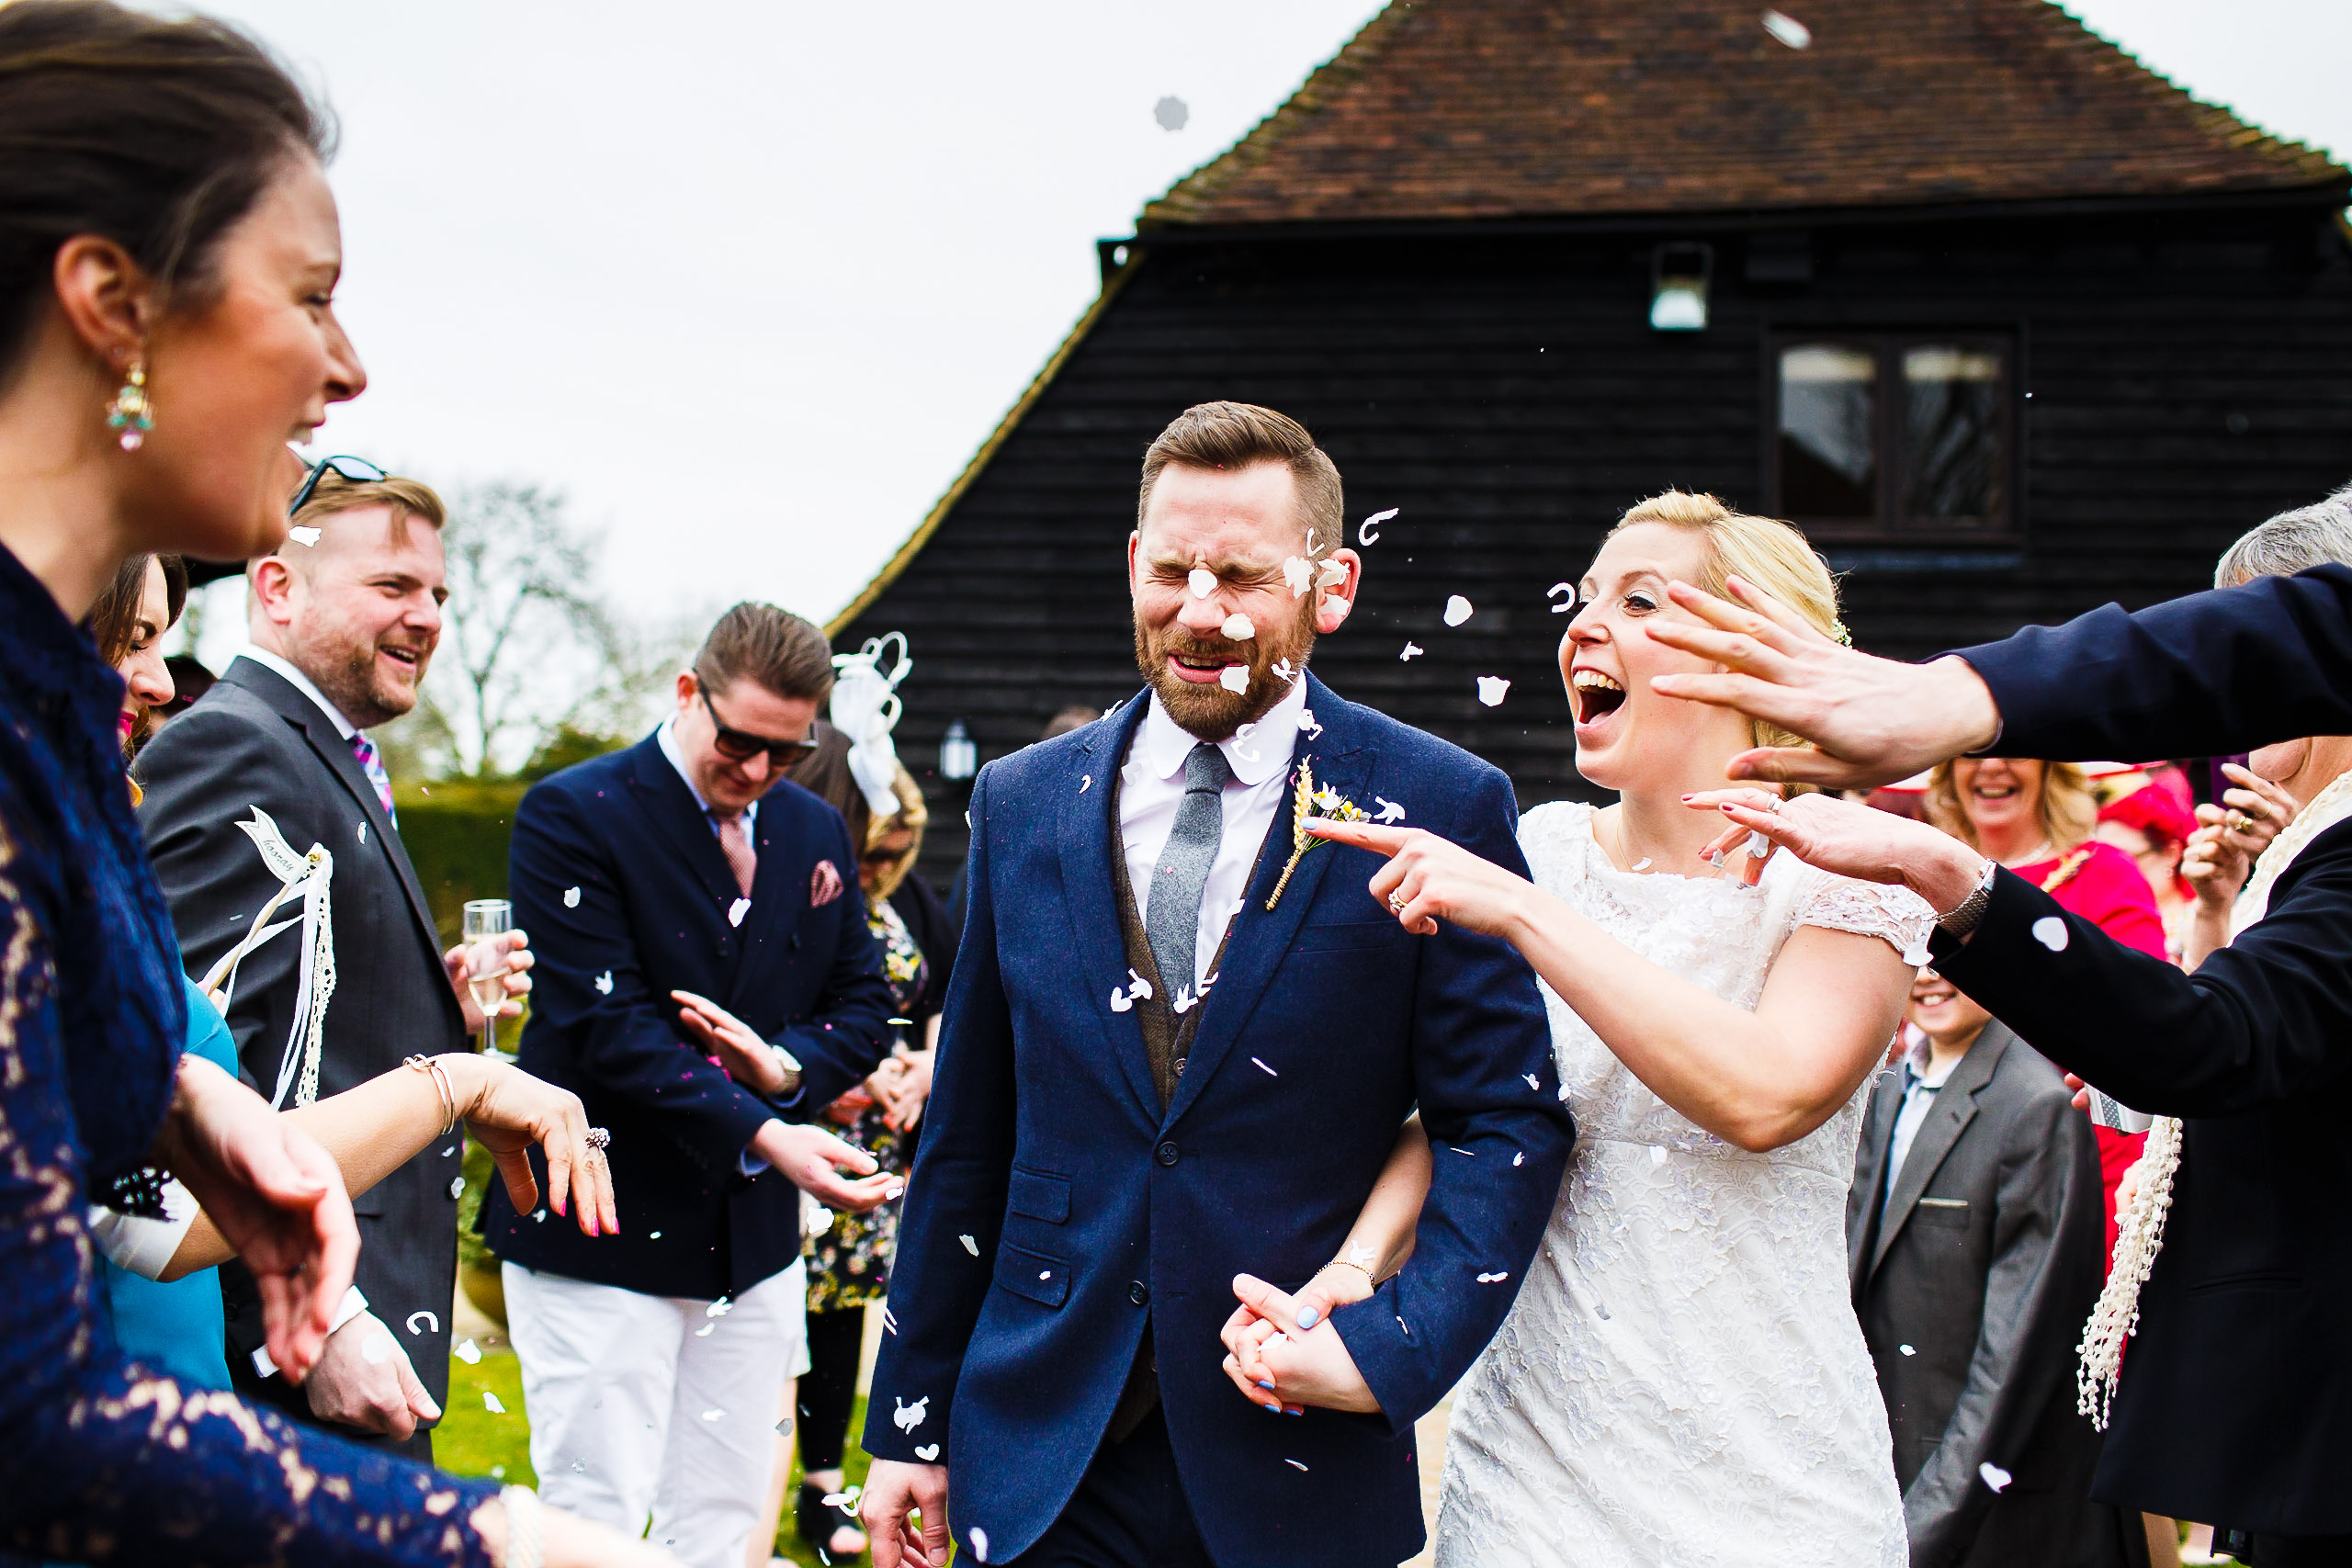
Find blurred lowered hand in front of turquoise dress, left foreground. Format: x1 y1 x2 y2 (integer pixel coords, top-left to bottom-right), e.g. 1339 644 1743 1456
155 1055 360 1382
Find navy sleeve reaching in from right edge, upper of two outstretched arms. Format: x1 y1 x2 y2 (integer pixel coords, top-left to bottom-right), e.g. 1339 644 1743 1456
1959 567 2352 760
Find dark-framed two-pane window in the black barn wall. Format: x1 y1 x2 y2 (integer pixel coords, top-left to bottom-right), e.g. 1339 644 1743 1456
1773 333 2013 536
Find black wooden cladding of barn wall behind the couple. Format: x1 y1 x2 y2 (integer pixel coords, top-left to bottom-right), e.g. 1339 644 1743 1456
837 207 2352 882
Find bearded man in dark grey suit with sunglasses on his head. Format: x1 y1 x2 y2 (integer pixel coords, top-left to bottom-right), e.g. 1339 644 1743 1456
136 470 520 1460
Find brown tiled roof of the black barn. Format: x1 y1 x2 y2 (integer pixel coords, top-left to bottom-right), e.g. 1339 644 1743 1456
1141 0 2352 228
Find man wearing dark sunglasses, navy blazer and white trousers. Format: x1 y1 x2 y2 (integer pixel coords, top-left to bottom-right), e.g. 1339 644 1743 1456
482 604 899 1568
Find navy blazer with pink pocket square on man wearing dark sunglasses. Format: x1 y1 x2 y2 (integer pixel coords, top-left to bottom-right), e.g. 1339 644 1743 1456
482 736 891 1298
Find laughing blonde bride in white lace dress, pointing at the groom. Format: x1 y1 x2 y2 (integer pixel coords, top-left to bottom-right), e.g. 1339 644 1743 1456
1226 491 1933 1568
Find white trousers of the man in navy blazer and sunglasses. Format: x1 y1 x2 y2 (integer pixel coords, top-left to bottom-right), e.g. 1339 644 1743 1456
501 1260 809 1568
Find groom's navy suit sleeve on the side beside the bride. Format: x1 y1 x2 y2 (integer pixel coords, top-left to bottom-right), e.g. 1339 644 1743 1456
1331 769 1576 1434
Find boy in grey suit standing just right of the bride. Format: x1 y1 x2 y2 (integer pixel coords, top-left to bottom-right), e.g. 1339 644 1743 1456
1847 968 2147 1568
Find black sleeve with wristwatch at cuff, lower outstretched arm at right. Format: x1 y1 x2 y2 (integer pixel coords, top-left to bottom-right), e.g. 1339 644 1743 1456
1931 823 2352 1117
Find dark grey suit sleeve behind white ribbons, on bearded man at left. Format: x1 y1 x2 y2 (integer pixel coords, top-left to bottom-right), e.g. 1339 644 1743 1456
139 705 320 1096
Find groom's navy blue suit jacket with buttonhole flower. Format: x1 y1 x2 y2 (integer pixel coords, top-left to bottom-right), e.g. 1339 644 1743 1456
865 677 1576 1568
